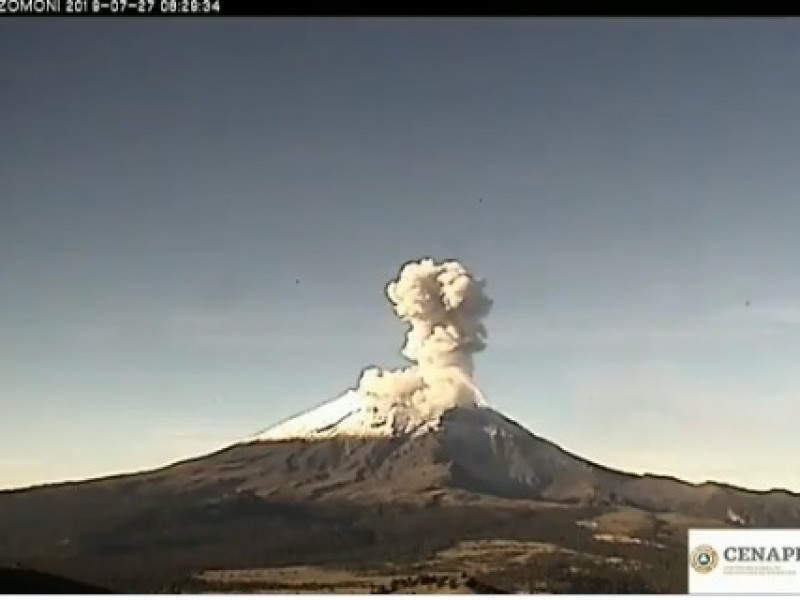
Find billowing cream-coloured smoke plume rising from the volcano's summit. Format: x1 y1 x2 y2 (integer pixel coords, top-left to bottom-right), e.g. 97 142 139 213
358 258 492 422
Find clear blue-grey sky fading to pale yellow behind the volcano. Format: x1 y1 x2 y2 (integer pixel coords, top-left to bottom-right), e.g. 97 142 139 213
0 19 800 490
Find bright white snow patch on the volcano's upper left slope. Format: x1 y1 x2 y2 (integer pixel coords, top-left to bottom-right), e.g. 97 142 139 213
250 390 462 441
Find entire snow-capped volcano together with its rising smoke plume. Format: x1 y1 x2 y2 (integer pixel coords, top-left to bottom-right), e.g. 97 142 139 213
0 259 800 593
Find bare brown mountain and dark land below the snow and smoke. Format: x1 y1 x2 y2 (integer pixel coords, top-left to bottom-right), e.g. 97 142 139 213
0 409 800 593
